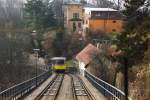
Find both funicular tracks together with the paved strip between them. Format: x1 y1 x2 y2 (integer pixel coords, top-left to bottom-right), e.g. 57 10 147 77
34 74 96 100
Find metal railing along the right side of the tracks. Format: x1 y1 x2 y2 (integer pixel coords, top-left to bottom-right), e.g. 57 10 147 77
85 71 125 100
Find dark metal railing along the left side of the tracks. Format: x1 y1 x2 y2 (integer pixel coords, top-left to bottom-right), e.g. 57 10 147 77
0 71 52 100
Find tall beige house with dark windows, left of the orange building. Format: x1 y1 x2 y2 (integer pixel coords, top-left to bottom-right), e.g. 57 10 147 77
64 2 83 32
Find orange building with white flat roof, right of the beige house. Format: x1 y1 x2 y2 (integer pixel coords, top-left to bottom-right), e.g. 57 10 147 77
83 7 123 33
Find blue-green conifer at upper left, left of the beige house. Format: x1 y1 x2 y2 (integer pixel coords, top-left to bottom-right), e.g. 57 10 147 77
24 0 56 54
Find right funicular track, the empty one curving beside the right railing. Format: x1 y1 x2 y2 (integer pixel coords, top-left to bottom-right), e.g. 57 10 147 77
70 75 96 100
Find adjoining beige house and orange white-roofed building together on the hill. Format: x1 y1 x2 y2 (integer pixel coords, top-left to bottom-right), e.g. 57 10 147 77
64 2 123 33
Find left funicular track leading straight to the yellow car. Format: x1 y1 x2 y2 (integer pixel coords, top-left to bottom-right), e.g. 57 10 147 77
35 74 64 100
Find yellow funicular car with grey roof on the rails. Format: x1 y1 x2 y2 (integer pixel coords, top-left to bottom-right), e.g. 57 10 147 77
51 57 66 73
